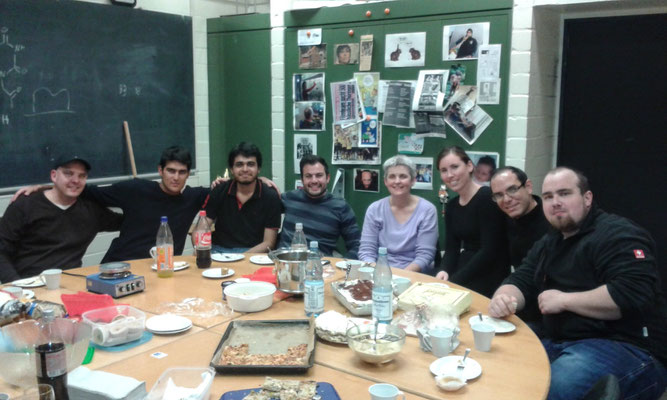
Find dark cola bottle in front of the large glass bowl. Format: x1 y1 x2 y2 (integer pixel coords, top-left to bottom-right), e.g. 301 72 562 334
35 310 69 400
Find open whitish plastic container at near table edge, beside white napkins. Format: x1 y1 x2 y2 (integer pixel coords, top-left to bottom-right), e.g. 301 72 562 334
146 367 215 400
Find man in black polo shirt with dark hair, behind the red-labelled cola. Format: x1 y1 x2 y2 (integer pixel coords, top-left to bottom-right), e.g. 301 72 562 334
206 142 282 253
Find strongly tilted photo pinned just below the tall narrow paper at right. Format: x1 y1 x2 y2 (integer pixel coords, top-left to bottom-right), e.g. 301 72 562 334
445 86 493 144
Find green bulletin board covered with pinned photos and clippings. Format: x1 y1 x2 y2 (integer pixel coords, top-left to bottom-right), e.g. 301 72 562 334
285 0 512 245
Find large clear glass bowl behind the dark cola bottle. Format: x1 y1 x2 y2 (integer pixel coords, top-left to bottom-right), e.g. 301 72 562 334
0 318 92 387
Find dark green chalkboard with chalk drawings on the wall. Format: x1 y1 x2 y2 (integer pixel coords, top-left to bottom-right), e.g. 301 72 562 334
0 0 195 188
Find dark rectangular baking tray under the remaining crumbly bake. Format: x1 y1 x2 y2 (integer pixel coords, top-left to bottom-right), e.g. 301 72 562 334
211 319 316 374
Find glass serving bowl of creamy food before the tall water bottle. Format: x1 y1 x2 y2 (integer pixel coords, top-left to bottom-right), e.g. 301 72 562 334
346 324 405 364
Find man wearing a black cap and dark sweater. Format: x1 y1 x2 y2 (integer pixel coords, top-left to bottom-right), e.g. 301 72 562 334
0 156 122 283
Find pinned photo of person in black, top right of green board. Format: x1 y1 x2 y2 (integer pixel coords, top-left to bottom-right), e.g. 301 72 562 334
442 22 490 61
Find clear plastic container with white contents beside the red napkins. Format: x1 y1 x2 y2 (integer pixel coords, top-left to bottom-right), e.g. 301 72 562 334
81 306 146 346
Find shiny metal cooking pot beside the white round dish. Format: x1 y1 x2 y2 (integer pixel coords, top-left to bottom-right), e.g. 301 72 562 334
269 249 309 294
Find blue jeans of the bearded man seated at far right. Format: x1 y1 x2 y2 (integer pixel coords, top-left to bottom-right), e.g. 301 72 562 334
542 339 667 400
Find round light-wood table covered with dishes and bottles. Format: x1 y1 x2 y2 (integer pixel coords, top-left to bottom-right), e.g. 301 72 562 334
0 255 550 400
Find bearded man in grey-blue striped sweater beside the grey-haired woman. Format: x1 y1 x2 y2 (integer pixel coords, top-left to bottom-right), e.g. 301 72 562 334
280 154 361 259
